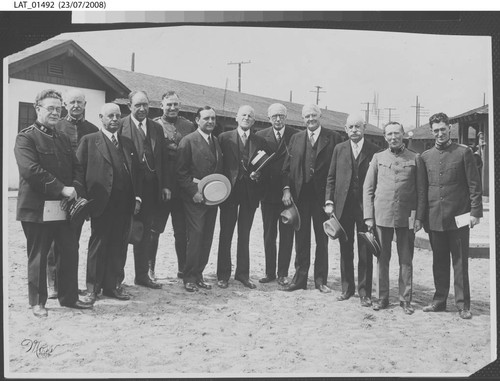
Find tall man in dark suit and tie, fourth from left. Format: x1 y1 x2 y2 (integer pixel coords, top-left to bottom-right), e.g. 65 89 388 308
119 91 173 288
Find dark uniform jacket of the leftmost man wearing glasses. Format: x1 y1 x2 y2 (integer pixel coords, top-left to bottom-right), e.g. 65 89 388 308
14 122 86 222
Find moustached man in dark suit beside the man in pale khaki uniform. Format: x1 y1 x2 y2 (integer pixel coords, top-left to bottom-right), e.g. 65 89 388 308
325 115 379 307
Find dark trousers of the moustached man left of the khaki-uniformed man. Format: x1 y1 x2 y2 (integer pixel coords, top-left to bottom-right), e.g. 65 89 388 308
339 197 373 298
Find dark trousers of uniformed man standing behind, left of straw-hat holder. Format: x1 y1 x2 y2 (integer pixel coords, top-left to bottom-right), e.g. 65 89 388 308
149 198 187 272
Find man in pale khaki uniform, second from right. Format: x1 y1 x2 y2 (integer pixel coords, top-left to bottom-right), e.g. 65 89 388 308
363 122 425 315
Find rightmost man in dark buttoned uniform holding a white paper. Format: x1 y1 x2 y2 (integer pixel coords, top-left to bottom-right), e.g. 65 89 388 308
422 113 483 319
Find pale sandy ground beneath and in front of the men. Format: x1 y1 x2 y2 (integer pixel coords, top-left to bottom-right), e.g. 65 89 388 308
4 199 492 377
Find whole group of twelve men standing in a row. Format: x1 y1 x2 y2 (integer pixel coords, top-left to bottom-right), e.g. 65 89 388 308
15 90 482 318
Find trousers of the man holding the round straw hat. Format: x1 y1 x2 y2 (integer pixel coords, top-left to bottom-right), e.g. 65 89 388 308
183 201 217 284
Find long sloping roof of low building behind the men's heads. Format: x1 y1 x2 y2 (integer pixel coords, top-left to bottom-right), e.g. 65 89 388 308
107 67 382 136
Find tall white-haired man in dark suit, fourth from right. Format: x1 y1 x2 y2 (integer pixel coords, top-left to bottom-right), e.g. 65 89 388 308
283 104 342 292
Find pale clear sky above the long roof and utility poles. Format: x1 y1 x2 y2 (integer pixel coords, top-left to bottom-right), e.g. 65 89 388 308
55 26 491 129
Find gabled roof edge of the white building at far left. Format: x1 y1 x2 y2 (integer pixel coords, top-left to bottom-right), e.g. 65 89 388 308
8 39 130 95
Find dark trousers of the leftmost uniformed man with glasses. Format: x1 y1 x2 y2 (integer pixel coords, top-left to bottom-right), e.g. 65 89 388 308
21 221 78 306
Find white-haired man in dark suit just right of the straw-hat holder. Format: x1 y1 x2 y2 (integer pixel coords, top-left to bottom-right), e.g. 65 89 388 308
217 106 268 289
